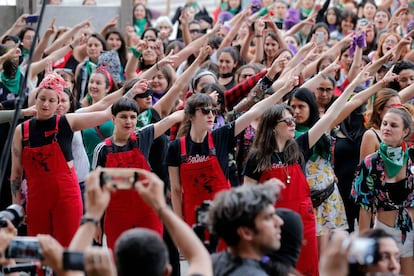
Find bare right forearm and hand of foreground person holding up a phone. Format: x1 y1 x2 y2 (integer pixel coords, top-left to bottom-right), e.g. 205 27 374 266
136 169 213 276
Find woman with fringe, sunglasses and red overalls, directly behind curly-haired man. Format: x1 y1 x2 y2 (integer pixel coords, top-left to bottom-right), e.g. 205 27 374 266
167 74 293 226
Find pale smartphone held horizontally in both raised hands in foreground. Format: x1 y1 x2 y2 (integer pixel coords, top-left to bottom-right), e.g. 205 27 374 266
100 168 139 191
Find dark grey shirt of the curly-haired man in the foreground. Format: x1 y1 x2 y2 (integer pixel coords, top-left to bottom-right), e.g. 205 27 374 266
211 251 268 276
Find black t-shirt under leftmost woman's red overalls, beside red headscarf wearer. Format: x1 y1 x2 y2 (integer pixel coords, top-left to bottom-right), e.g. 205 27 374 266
22 115 73 162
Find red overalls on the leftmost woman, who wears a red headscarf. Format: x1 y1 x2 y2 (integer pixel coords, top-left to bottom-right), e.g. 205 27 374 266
22 116 82 246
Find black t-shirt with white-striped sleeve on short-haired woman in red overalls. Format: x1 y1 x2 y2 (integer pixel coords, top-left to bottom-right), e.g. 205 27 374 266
92 125 154 168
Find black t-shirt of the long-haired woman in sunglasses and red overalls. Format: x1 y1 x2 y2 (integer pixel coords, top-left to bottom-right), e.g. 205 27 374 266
243 132 312 181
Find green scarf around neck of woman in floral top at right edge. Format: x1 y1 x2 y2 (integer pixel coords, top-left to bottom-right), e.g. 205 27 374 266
378 141 408 178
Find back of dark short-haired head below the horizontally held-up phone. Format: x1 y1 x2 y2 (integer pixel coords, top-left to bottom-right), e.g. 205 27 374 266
115 228 170 276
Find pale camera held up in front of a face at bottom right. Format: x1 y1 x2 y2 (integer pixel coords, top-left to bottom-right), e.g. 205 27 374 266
342 238 379 265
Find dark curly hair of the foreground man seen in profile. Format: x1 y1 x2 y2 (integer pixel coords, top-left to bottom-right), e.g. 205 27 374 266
208 183 279 246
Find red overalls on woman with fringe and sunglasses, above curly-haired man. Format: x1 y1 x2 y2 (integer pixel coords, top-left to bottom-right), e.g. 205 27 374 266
180 132 230 227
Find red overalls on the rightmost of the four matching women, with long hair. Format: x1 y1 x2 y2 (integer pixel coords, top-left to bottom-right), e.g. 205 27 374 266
259 164 319 276
